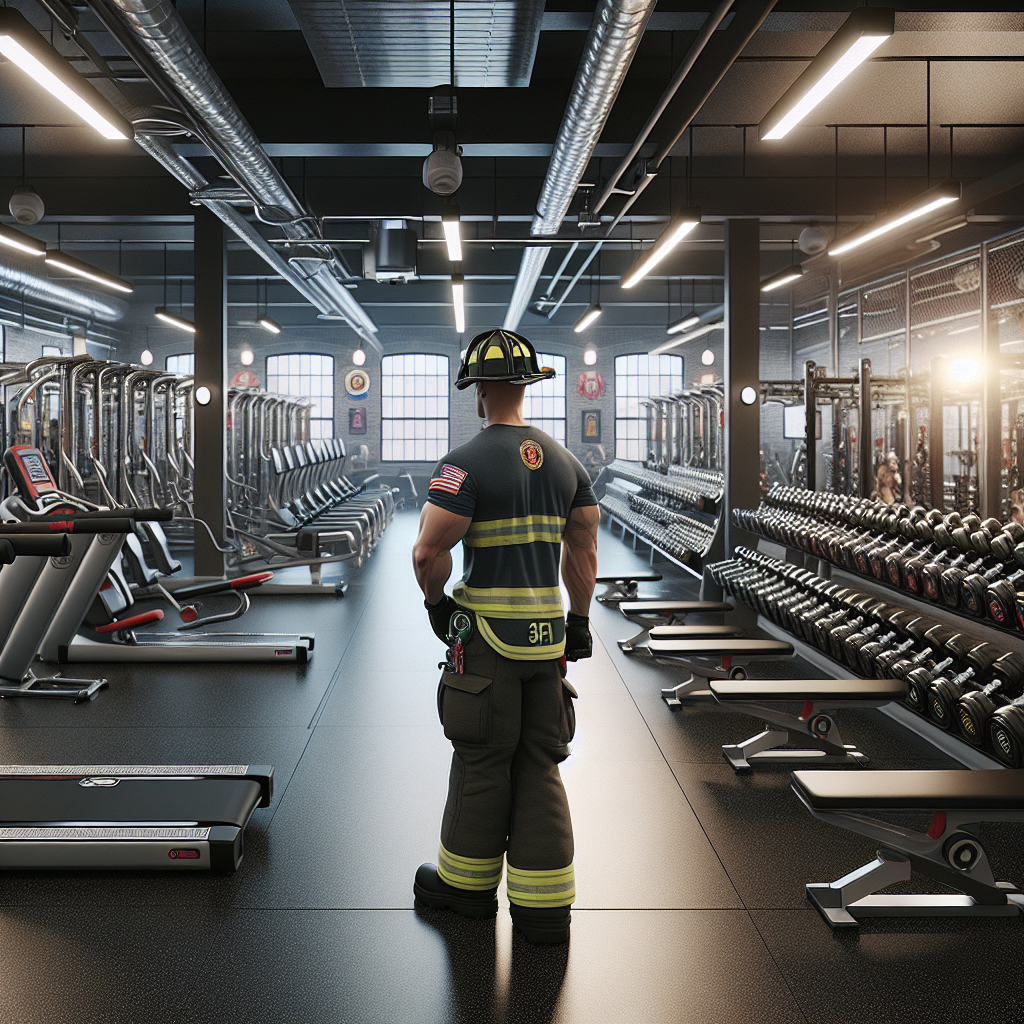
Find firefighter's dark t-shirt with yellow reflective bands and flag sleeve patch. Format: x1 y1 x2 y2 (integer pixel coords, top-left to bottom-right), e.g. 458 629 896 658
427 423 597 660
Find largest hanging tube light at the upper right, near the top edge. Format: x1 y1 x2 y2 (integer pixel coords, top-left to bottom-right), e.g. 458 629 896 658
758 7 896 139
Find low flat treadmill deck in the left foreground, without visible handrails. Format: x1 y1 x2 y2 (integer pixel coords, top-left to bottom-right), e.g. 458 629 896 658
0 765 273 871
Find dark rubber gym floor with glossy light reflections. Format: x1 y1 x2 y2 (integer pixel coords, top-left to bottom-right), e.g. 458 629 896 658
0 510 1024 1024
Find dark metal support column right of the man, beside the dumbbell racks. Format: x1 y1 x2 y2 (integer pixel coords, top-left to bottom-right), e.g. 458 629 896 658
723 219 761 557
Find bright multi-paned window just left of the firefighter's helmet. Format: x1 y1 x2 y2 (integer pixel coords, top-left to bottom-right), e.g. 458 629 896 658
381 352 449 462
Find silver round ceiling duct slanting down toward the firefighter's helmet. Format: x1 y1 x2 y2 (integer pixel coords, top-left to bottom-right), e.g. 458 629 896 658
503 0 655 331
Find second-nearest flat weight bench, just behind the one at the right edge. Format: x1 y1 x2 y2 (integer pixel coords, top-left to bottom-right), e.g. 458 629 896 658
708 679 907 772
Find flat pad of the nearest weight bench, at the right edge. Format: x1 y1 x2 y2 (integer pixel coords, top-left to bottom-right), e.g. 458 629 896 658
793 768 1024 811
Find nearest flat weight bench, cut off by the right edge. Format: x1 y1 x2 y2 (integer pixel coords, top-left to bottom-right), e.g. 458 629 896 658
793 768 1024 928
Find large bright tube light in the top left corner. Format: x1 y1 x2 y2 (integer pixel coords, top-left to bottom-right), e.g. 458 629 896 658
0 7 135 138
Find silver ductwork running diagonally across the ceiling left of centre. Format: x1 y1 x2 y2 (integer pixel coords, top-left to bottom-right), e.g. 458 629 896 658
82 0 380 349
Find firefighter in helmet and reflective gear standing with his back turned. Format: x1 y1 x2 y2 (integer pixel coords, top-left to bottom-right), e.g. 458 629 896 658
413 330 600 944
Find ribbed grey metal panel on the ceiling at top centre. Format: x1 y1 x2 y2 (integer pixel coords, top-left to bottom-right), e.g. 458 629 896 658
290 0 544 89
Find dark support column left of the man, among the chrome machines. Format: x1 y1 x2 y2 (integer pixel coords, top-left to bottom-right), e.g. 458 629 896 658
193 207 227 577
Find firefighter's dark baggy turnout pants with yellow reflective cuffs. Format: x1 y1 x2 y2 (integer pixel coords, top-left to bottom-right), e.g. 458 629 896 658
437 633 575 907
